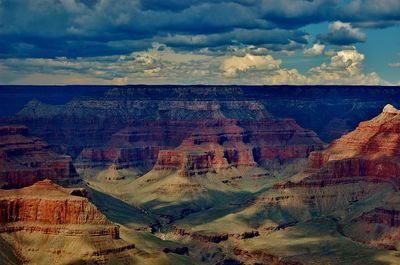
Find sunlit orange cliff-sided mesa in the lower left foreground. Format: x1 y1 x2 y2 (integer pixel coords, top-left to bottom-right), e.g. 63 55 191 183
0 179 119 238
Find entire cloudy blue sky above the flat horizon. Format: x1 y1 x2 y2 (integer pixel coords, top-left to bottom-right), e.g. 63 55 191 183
0 0 400 85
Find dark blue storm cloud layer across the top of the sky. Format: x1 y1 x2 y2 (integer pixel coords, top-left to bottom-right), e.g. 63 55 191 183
0 0 400 58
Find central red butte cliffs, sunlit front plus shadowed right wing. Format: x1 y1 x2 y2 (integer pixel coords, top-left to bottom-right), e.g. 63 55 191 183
154 119 322 176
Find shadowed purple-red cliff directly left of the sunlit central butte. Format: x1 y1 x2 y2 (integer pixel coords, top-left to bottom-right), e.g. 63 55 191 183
75 120 197 173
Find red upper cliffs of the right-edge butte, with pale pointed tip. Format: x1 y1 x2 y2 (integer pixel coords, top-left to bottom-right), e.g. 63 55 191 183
309 105 400 186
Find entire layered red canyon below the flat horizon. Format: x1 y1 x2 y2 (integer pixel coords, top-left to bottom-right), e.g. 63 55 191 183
0 86 400 265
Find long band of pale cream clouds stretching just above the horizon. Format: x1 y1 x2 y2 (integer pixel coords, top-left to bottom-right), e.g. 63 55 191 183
0 44 387 85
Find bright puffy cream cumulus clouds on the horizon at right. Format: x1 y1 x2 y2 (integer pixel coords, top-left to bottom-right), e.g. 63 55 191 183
221 47 388 85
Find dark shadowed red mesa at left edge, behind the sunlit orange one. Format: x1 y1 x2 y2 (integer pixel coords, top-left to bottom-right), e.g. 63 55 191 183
0 125 80 188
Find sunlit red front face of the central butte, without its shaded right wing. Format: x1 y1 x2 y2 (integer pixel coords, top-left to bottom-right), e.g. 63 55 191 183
154 119 256 176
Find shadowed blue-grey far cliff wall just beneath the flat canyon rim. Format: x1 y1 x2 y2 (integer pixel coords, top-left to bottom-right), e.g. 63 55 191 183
16 88 270 157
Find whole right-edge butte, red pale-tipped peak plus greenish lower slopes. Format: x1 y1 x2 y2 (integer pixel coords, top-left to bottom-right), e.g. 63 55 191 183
247 105 400 249
